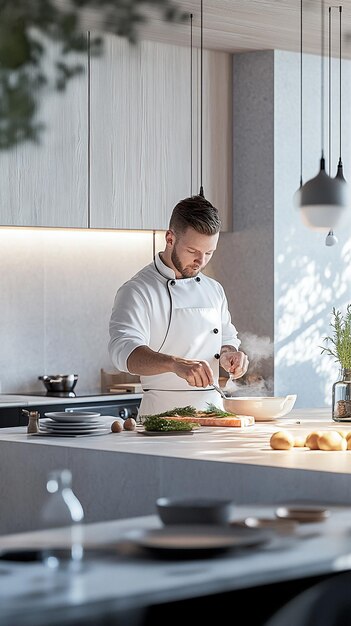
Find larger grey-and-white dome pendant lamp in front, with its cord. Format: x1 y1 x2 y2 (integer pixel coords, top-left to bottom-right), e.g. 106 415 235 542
295 0 347 232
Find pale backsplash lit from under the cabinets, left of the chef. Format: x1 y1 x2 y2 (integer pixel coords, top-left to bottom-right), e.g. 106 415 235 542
0 228 153 393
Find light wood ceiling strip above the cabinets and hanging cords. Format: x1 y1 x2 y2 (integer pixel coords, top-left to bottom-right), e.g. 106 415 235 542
78 0 351 58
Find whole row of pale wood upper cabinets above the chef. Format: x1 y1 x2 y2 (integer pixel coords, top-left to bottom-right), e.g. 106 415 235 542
0 33 232 230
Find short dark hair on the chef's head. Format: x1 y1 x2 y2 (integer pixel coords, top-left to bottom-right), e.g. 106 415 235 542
169 196 221 235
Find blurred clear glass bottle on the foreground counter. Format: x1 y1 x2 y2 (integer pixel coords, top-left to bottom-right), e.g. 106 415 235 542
41 469 84 570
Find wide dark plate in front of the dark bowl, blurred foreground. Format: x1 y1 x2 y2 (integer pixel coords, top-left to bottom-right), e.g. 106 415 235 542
128 524 272 559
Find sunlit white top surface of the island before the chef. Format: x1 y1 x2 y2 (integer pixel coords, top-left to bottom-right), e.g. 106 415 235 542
0 409 351 474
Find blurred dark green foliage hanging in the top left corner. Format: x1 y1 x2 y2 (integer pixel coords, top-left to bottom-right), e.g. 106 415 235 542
0 0 189 150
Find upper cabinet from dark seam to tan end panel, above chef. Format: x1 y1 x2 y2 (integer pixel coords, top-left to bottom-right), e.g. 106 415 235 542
90 35 232 230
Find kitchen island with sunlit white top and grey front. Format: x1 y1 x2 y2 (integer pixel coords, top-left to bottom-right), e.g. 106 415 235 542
0 409 351 534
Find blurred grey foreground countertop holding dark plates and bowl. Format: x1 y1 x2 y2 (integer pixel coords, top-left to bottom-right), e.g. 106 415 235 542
0 505 351 626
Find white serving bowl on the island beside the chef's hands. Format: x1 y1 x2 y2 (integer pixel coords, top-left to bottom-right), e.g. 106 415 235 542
223 394 297 422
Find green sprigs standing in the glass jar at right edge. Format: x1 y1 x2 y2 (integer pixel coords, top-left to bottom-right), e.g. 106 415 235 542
320 304 351 369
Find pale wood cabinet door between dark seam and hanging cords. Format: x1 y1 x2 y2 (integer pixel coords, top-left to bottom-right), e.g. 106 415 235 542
90 35 190 230
